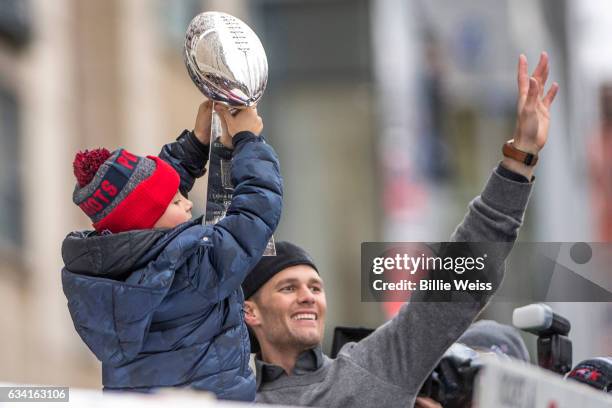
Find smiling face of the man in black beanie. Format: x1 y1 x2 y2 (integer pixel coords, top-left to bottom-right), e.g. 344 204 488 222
245 265 327 351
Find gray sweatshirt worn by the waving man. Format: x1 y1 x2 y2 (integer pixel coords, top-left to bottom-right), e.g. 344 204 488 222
256 166 533 408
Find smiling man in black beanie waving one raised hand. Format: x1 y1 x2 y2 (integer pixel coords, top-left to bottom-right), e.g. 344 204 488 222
243 53 558 408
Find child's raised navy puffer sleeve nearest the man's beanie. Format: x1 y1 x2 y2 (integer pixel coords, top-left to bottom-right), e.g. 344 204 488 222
202 132 283 299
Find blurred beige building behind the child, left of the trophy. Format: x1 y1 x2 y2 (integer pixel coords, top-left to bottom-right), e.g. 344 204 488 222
0 0 220 387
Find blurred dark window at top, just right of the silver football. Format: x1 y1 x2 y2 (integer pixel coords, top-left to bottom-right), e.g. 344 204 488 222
253 0 371 82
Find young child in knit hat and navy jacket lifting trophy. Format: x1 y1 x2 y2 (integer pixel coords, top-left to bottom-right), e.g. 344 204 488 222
62 102 282 401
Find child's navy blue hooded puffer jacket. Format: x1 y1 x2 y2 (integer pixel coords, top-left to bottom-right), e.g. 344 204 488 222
62 132 282 401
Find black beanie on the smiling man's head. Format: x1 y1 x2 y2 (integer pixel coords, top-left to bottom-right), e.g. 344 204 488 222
242 241 319 299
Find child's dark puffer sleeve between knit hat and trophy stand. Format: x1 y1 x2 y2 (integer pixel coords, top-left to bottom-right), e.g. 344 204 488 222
159 130 210 197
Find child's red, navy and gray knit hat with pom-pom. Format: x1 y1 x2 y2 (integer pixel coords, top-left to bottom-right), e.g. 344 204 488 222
72 149 180 233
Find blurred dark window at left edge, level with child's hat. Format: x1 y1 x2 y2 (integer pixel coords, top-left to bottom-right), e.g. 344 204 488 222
0 88 22 249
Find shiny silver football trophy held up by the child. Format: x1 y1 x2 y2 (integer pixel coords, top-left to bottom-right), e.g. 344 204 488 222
184 11 276 255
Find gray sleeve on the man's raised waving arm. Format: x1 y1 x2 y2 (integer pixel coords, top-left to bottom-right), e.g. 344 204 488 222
340 170 532 394
